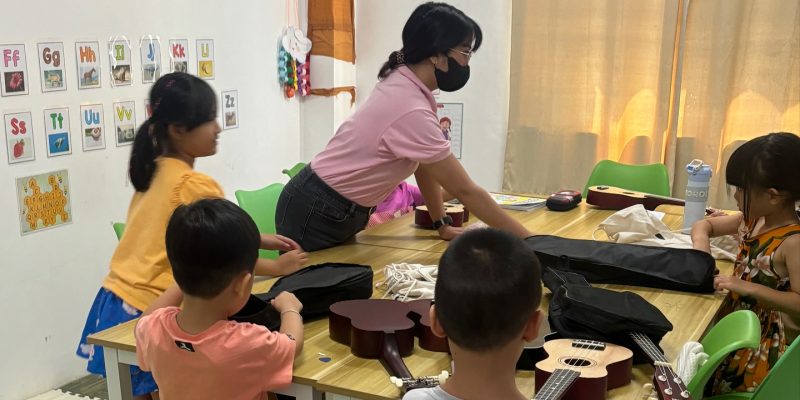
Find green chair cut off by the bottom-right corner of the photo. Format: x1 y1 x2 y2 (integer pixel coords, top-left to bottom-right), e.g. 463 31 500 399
707 339 800 400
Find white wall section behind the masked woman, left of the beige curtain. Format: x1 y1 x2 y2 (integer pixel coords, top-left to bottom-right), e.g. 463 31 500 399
356 0 511 190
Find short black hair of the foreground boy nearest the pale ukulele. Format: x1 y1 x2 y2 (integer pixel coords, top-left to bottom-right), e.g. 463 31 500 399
434 228 542 352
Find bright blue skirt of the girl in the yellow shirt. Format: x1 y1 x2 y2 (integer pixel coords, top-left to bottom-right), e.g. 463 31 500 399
77 288 158 396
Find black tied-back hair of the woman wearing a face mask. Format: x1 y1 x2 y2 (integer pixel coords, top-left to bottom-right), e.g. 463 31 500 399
378 2 483 79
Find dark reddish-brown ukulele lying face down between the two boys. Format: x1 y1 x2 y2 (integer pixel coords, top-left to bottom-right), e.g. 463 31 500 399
328 299 449 392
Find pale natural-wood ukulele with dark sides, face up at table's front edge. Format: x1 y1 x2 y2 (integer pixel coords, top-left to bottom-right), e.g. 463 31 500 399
533 339 633 400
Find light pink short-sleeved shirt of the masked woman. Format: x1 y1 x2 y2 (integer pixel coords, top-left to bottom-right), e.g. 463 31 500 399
311 66 450 207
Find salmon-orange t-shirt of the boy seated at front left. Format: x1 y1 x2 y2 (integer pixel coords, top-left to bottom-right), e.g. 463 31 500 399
134 307 295 400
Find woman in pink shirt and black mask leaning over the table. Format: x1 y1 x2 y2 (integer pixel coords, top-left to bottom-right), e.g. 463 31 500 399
275 3 531 251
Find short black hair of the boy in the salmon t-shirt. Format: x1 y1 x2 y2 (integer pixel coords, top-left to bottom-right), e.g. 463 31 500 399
166 199 261 299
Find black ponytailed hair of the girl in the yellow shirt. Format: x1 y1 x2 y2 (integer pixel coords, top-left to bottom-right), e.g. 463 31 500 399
128 72 217 192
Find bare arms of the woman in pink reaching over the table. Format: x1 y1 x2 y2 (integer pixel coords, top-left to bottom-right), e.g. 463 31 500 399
415 154 532 238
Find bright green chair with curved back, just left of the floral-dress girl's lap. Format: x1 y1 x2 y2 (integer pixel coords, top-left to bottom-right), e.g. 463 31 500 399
686 310 761 399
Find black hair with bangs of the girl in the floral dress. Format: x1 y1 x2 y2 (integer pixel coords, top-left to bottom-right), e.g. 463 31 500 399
725 132 800 223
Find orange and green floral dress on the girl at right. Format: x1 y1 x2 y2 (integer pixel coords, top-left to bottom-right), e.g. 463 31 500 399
711 224 800 395
